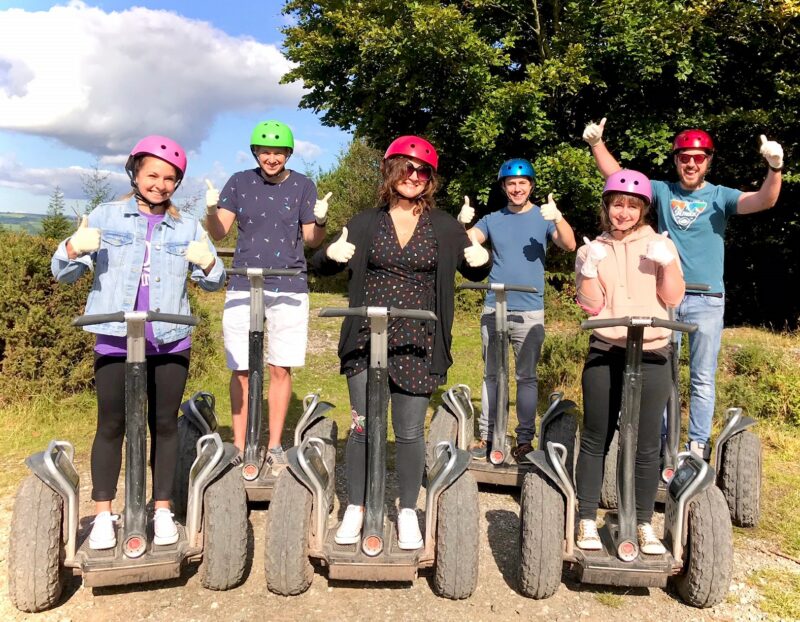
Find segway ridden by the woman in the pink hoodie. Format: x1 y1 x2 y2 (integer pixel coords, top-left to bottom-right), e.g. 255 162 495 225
520 317 733 607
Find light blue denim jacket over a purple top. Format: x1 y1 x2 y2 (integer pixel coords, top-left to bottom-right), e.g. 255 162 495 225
50 198 225 343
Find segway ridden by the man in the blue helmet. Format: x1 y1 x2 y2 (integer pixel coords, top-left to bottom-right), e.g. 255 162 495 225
425 283 578 487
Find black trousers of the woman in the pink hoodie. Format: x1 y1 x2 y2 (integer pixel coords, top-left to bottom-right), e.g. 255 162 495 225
576 348 671 523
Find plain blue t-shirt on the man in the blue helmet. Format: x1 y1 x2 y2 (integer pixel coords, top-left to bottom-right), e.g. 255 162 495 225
475 205 556 311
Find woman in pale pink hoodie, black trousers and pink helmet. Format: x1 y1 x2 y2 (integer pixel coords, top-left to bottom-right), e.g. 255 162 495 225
575 169 684 555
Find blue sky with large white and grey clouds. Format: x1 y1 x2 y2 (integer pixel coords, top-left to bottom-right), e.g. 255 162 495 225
0 0 350 213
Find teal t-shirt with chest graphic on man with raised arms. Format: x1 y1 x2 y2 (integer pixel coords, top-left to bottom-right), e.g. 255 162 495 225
652 181 742 293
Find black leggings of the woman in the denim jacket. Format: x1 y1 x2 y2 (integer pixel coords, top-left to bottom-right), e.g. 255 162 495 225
92 350 190 501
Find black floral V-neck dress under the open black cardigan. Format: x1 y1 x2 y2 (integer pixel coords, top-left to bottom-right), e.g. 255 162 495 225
343 211 443 395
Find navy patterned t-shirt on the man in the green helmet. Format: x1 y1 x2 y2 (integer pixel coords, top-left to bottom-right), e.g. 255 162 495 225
219 168 317 294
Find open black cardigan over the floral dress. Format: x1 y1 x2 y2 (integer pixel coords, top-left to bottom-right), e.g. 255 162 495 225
310 206 492 381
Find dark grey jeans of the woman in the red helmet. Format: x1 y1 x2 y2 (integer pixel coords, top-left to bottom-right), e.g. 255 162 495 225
345 371 431 509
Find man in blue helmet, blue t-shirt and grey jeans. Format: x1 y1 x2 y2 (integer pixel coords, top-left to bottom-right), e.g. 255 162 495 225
458 158 575 462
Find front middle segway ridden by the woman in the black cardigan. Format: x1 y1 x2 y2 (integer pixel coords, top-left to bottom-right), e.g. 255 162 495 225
266 307 479 599
